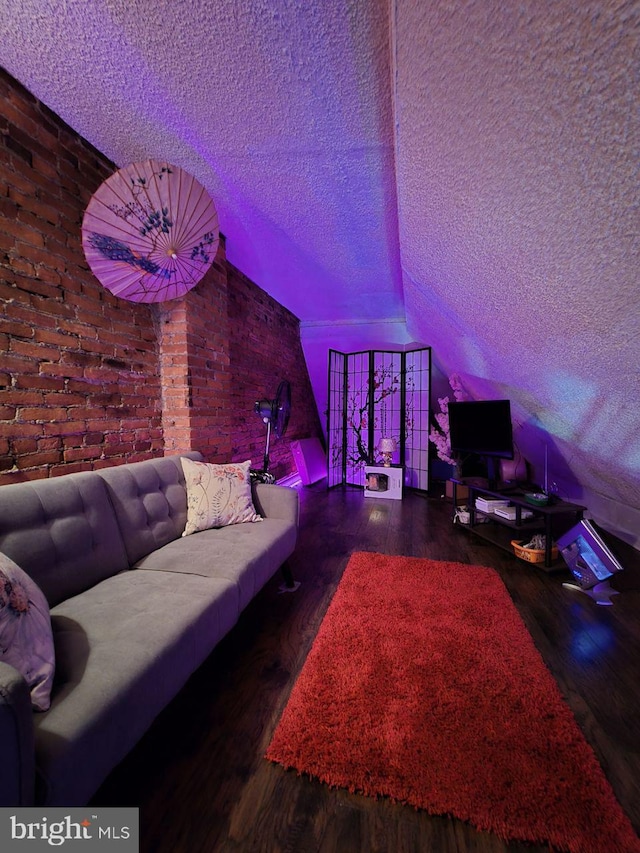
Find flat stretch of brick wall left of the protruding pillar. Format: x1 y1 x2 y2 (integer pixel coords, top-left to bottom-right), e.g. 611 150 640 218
0 68 163 482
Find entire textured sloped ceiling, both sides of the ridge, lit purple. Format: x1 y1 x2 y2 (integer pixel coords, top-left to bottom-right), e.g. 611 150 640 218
0 0 640 539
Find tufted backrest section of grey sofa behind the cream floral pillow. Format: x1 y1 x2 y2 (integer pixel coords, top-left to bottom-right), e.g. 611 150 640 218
96 451 202 565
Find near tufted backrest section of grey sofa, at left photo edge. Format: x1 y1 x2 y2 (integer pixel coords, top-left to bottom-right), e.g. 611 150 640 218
0 471 128 606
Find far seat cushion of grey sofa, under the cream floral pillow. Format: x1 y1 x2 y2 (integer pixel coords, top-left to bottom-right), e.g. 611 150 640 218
136 518 297 609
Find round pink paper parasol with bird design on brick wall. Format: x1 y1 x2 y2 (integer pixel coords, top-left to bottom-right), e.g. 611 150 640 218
82 160 220 302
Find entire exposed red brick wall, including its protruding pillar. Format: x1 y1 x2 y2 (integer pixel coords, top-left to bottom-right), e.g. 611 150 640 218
0 71 320 484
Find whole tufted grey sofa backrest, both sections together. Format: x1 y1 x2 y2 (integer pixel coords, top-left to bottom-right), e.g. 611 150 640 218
0 451 202 607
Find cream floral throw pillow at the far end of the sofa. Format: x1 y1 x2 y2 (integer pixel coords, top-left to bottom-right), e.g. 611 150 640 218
181 457 262 536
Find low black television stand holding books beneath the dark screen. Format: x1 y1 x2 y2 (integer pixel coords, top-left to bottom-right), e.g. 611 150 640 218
451 478 586 571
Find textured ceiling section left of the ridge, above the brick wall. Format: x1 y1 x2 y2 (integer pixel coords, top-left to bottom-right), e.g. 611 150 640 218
0 0 404 321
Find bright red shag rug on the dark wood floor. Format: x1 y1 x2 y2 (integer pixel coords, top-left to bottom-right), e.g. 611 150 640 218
266 553 640 853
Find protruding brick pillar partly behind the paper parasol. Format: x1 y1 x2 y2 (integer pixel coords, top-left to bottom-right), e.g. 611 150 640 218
155 236 232 462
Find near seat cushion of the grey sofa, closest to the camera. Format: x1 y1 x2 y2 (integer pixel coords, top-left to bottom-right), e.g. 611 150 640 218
35 571 239 806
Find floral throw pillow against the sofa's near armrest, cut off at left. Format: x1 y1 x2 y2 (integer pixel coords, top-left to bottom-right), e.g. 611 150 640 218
0 554 55 711
